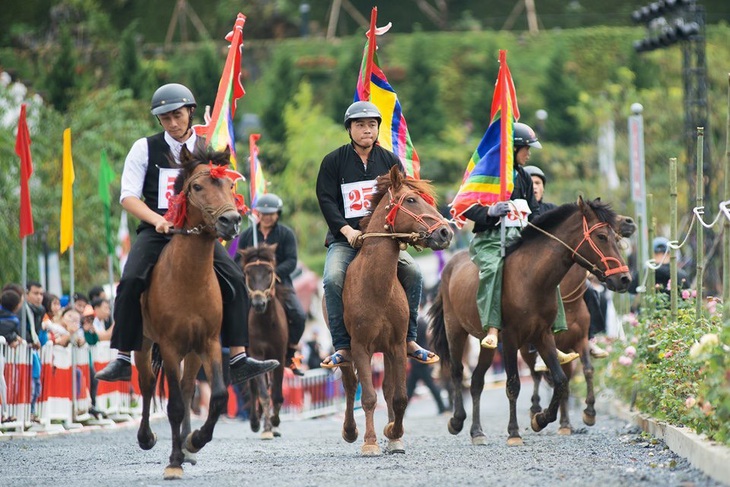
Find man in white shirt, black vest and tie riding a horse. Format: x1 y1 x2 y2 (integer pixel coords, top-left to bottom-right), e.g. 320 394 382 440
96 83 279 383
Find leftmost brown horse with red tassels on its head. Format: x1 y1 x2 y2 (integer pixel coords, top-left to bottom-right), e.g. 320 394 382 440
134 146 241 480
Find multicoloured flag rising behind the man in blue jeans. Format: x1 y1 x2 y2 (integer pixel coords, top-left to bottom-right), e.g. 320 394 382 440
355 7 421 179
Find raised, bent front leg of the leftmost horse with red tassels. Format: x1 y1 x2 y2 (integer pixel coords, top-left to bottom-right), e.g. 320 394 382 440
185 344 228 453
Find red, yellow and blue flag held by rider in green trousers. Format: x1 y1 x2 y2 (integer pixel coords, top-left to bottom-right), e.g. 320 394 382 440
451 50 520 225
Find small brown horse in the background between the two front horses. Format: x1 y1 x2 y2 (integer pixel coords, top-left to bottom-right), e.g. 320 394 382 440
238 244 291 440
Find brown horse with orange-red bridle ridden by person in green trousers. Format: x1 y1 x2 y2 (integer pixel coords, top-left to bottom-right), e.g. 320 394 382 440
429 197 631 446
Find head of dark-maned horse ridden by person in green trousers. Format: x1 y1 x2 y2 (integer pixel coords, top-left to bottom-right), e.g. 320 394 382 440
573 196 636 292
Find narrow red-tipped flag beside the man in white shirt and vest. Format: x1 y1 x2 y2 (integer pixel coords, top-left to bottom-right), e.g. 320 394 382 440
195 13 246 169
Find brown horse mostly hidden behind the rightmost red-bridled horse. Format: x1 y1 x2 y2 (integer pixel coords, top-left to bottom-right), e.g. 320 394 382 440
520 215 636 435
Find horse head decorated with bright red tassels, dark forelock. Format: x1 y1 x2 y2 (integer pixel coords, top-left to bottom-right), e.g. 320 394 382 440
166 145 245 240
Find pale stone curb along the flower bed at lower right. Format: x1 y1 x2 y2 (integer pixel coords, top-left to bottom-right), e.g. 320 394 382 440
596 398 730 486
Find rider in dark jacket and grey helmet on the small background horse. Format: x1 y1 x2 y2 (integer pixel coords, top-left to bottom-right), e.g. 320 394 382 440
235 193 307 376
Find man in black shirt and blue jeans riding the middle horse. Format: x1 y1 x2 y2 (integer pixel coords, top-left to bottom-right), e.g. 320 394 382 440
317 101 438 369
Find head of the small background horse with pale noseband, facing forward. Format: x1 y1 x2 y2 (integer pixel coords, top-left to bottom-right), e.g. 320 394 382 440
238 244 277 313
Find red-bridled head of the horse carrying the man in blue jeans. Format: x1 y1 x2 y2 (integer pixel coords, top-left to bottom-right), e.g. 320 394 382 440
360 166 454 250
